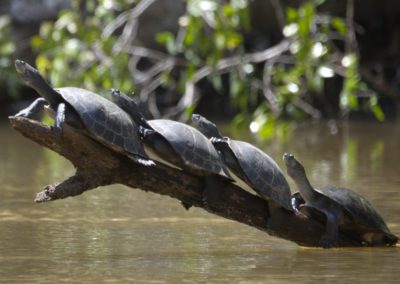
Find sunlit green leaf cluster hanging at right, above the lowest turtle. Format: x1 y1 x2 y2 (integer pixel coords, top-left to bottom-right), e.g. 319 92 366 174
234 1 384 138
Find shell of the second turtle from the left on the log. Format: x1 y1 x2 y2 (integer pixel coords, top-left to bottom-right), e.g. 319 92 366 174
148 119 229 177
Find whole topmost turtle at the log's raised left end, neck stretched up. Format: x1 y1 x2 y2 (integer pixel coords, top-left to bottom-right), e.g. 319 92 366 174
15 60 155 166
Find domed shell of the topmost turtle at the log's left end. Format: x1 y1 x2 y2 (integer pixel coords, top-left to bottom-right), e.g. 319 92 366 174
55 87 146 158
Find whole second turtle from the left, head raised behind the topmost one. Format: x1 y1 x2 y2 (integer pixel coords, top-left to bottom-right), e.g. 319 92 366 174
111 89 232 209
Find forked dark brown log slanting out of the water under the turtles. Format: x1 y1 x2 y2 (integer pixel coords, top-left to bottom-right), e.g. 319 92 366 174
10 117 360 246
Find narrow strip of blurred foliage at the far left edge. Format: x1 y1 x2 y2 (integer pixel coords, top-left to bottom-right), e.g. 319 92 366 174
0 16 19 98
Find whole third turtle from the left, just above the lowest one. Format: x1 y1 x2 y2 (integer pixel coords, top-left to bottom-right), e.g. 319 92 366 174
192 114 292 211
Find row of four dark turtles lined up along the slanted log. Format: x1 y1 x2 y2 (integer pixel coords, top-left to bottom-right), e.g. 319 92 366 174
15 60 398 248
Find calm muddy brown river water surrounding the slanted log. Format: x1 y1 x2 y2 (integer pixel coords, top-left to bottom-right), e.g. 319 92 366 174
0 118 400 283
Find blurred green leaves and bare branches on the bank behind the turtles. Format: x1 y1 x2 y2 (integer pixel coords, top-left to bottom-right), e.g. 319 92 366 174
0 0 398 137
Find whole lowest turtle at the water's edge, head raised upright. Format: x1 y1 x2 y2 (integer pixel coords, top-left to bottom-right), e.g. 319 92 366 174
283 153 398 248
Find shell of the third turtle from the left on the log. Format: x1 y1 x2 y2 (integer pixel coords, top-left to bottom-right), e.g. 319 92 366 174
229 140 292 210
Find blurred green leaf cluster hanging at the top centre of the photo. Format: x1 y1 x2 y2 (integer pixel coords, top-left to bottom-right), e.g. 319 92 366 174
156 0 249 92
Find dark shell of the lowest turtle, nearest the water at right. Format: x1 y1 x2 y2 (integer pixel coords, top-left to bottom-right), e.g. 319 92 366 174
318 186 397 244
